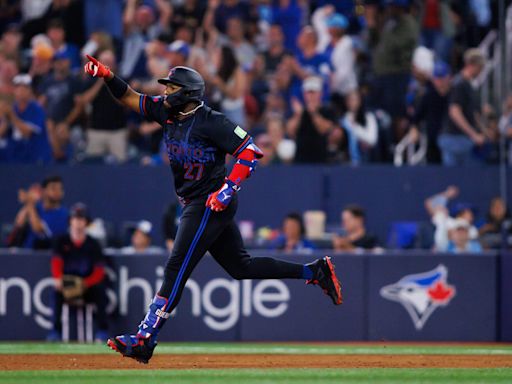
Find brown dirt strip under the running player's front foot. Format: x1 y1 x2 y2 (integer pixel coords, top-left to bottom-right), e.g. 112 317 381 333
0 354 512 371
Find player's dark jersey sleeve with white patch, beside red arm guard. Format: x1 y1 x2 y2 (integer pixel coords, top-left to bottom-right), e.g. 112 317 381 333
209 115 251 157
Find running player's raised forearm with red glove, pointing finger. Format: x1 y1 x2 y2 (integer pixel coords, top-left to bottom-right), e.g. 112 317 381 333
84 55 143 113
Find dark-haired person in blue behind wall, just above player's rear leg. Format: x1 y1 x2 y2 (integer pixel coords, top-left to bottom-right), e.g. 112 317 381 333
272 213 315 253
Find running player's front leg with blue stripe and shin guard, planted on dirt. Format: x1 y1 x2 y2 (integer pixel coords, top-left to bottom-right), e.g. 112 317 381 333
108 201 234 363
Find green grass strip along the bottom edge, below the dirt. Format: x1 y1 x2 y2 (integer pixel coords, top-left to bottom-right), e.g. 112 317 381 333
0 368 512 384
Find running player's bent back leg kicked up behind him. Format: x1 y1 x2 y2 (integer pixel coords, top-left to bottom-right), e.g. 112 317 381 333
209 221 342 305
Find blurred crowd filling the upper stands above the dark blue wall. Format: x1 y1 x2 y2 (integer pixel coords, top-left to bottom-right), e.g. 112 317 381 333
0 0 512 166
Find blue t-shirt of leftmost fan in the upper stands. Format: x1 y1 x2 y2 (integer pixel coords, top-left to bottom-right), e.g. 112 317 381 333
5 100 52 164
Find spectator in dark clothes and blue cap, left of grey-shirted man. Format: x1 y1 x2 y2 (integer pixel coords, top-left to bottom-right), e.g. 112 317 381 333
411 61 451 164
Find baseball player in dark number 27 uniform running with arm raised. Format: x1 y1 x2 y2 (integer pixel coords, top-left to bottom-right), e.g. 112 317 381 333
84 56 342 363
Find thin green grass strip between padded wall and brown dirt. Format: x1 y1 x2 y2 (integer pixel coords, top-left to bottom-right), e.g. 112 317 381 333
0 343 512 358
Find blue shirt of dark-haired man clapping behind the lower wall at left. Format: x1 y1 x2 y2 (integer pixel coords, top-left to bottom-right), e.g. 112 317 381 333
24 203 69 248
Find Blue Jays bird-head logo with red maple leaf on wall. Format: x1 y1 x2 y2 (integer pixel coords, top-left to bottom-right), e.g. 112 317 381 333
380 264 456 330
